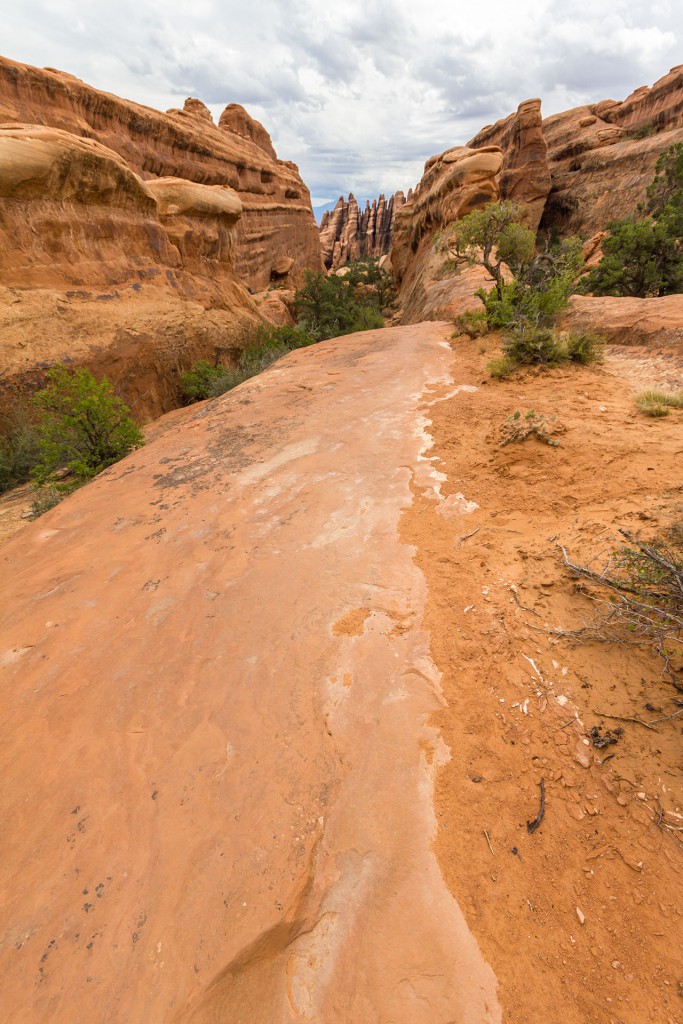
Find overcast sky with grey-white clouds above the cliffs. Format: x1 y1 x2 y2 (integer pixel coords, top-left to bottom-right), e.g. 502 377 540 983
0 0 683 205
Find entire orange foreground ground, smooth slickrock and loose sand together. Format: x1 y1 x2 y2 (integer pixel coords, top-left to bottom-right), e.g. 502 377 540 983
0 324 683 1024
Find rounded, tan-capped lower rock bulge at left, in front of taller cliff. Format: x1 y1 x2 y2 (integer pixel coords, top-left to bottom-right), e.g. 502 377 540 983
0 124 259 420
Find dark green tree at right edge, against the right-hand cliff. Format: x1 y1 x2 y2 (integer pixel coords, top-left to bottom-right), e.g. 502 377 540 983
581 142 683 298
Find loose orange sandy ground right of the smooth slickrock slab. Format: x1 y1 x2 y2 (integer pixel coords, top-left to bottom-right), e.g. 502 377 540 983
403 331 683 1024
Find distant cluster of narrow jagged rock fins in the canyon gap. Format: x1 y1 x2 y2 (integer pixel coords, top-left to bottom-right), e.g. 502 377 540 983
321 189 413 269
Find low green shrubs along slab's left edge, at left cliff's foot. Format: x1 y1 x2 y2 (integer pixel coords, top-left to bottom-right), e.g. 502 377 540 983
180 324 315 404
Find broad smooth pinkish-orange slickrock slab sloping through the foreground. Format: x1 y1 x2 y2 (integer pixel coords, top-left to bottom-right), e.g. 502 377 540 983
0 325 501 1024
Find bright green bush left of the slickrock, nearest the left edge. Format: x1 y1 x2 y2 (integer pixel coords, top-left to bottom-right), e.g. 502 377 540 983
32 366 144 487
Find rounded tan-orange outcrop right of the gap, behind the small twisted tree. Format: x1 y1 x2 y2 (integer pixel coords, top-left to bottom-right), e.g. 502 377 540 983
390 146 503 324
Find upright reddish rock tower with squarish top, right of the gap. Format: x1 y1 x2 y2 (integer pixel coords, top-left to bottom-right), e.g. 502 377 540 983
468 99 551 231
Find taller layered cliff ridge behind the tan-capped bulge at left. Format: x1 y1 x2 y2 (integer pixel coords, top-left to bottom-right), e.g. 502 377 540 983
0 58 321 291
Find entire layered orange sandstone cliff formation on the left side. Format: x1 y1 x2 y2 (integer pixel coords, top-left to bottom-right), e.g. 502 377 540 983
0 58 321 420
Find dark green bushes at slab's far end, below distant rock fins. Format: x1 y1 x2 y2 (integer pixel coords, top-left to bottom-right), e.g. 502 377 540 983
294 270 384 341
